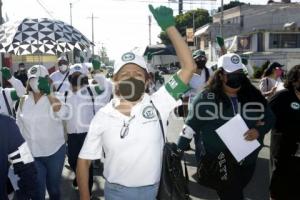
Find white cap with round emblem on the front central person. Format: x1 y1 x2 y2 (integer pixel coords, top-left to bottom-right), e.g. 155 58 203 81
114 52 148 75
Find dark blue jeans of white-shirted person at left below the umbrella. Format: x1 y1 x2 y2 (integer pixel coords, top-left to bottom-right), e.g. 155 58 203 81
34 144 66 200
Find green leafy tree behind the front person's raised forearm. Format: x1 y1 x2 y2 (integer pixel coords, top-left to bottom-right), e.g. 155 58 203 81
158 9 211 45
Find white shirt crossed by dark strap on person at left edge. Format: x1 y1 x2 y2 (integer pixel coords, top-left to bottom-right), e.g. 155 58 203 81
0 77 26 115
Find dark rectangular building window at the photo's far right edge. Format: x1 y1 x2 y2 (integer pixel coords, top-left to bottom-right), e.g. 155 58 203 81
269 33 300 49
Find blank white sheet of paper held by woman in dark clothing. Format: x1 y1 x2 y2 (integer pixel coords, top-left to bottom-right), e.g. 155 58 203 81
216 114 260 162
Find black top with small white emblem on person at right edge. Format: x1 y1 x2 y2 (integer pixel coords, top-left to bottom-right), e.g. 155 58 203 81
270 90 300 157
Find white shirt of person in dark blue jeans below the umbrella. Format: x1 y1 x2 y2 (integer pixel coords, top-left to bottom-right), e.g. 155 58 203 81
17 92 68 157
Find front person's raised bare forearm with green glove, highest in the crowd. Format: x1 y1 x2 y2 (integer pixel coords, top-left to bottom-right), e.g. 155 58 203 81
149 5 196 84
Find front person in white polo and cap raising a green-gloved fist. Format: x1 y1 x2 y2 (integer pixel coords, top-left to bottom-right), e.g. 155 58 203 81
77 3 196 200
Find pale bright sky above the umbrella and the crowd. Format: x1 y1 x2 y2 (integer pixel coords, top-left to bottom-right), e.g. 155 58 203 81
2 0 296 59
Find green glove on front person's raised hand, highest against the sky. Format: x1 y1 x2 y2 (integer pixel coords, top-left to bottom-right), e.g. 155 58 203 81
149 5 175 31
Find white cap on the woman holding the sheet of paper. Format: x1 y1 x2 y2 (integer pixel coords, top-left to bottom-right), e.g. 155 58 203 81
218 53 243 73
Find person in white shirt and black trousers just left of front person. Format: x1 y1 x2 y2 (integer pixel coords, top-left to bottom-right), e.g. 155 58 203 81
63 63 111 190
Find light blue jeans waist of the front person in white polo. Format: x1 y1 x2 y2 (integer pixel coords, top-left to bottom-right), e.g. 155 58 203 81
104 181 159 200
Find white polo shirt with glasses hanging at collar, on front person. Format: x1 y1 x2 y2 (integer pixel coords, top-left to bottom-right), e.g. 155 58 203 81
79 86 181 187
